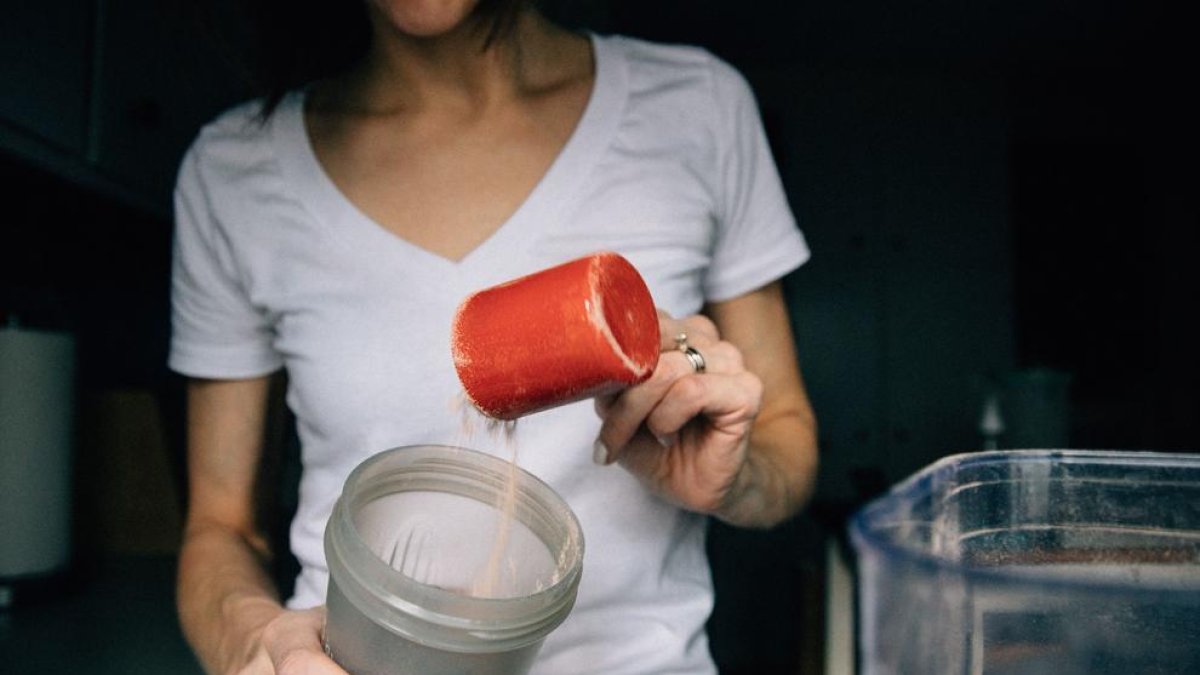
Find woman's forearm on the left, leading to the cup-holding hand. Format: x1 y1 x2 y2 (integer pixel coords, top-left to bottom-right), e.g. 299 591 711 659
178 525 283 673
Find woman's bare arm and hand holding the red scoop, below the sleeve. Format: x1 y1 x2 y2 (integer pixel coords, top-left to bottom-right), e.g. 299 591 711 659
596 282 817 527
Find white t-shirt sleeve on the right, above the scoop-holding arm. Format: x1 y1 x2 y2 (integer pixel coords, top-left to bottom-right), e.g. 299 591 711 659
704 59 809 301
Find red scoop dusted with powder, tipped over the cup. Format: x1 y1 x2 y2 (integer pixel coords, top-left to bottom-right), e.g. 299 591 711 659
450 252 659 419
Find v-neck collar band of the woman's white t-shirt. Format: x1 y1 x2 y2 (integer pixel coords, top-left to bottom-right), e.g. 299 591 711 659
272 34 628 269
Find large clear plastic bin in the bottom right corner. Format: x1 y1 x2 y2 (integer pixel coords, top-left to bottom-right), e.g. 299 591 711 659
851 450 1200 675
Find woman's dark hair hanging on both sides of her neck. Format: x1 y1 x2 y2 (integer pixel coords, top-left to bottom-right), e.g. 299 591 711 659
236 0 527 119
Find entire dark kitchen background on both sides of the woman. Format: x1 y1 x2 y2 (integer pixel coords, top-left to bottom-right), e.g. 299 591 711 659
0 0 1200 673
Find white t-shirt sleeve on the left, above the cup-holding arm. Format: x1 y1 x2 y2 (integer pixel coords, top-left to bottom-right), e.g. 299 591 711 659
168 145 282 378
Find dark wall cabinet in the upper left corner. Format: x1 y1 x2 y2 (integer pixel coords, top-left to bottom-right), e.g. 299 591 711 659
0 0 248 215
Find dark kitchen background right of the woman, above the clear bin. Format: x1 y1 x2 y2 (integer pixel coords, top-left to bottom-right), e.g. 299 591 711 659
593 0 1200 503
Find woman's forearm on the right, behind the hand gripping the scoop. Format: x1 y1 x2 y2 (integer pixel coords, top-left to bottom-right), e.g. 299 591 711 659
714 411 817 528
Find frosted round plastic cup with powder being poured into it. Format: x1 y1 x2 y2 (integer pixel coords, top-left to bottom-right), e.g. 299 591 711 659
325 446 583 675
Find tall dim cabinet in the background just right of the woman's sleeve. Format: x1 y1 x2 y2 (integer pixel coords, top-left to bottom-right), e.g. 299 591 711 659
750 68 1014 501
